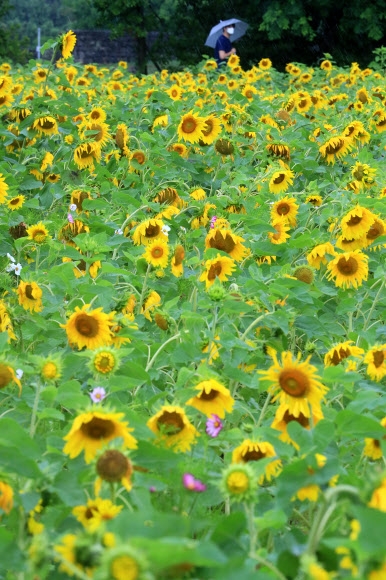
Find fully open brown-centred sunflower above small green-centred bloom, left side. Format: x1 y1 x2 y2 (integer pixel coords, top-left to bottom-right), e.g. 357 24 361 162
60 304 112 350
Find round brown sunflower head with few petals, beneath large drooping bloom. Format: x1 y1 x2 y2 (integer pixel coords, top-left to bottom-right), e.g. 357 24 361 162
95 449 133 495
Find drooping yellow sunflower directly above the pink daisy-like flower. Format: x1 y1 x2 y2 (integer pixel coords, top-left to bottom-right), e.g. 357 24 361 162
186 379 235 419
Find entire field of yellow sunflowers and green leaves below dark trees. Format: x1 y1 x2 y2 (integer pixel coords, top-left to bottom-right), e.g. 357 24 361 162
0 31 386 580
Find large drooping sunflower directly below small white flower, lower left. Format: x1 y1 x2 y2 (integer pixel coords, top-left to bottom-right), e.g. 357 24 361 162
63 411 137 463
